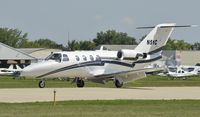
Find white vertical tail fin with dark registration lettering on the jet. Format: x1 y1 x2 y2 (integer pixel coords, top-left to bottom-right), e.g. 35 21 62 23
135 23 176 54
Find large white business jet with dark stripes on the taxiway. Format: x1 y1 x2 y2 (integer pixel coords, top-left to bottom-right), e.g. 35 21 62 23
19 23 190 88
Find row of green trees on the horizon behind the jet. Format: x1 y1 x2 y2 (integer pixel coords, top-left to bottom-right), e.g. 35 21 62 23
0 28 200 51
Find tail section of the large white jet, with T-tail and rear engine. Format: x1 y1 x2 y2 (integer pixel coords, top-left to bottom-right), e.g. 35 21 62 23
117 23 194 61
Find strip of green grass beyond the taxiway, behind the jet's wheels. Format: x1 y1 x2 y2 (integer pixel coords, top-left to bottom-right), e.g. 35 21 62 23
0 76 200 88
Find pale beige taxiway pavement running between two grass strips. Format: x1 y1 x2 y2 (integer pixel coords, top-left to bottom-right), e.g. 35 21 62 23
0 87 200 103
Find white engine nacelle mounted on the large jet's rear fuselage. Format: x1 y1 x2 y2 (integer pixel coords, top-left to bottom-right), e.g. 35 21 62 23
117 49 147 60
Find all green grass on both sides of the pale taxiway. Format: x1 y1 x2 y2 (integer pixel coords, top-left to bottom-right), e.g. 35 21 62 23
0 76 200 117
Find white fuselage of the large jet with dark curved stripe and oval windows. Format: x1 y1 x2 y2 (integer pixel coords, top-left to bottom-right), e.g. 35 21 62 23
21 50 149 78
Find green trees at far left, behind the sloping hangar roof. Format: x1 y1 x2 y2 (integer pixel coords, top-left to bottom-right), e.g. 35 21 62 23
0 28 62 49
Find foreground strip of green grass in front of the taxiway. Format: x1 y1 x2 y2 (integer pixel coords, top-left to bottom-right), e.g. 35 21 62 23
0 100 200 117
